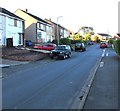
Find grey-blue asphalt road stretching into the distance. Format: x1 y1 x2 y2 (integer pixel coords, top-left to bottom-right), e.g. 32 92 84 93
2 45 103 109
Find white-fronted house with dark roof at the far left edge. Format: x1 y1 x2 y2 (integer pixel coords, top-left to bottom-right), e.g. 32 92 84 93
0 7 24 46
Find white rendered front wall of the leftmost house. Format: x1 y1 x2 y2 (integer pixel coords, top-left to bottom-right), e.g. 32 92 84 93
0 14 23 46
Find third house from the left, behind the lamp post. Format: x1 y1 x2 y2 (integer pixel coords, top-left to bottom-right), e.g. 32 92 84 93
45 19 71 39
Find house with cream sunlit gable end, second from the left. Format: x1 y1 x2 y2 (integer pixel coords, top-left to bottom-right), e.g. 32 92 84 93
15 9 54 43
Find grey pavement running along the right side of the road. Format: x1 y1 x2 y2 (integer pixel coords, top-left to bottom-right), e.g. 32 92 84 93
83 50 120 111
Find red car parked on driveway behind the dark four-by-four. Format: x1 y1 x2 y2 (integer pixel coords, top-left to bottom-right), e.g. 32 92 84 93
34 44 55 51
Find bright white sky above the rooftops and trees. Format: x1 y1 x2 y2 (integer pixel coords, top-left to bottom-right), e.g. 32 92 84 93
0 0 119 35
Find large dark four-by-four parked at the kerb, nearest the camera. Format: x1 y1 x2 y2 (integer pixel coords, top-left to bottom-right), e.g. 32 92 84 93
50 45 71 59
